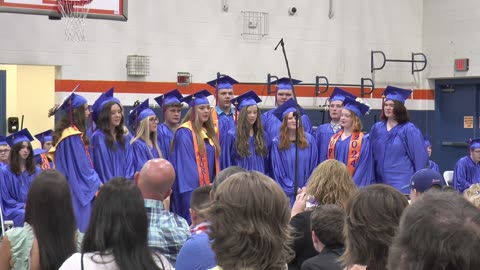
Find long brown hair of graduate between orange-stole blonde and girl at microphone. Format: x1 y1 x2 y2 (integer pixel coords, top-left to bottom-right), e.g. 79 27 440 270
235 105 267 158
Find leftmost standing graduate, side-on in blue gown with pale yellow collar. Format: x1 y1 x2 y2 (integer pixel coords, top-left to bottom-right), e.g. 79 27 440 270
49 86 101 232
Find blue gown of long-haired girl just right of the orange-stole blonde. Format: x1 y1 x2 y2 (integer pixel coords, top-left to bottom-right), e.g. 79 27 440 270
220 128 270 175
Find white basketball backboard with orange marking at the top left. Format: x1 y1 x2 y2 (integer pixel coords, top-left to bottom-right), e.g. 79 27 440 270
0 0 128 21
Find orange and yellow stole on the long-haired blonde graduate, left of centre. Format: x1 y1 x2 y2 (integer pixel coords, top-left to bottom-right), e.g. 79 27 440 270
180 121 220 186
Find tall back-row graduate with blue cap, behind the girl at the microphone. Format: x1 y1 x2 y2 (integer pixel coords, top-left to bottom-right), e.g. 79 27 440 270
262 78 313 139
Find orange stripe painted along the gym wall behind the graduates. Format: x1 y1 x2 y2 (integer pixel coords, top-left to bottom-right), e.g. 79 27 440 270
55 80 435 100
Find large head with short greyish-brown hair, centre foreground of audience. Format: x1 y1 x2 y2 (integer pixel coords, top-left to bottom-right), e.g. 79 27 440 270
209 171 290 269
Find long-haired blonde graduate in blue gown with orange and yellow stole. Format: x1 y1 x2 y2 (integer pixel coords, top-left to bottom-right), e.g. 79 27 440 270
170 90 221 223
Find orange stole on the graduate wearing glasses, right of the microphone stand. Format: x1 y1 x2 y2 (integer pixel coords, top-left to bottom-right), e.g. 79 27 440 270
328 129 363 176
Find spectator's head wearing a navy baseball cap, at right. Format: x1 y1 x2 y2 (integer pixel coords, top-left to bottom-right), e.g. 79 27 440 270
410 169 445 203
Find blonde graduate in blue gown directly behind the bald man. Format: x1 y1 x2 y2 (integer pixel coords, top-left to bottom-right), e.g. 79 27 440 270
128 98 163 172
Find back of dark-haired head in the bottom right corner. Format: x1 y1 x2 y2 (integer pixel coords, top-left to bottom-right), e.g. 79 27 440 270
388 192 480 270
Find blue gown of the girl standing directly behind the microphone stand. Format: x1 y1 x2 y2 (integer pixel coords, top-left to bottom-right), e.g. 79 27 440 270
271 133 318 206
